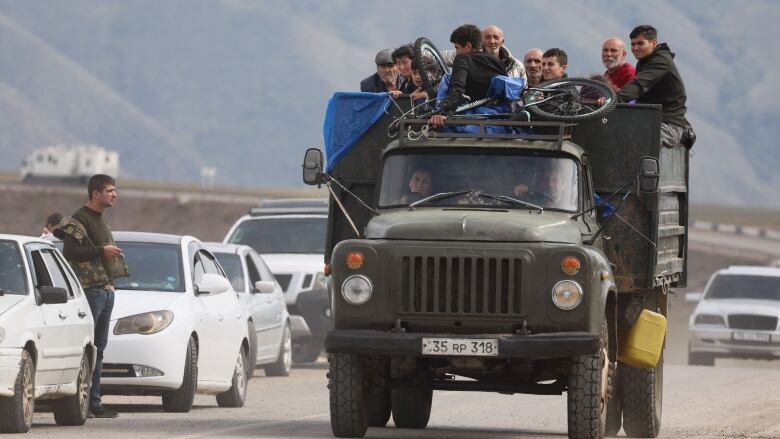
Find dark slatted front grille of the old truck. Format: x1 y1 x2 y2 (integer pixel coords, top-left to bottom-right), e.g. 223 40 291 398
400 256 522 315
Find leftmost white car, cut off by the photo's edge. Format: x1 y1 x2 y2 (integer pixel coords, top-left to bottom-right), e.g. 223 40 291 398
0 235 96 433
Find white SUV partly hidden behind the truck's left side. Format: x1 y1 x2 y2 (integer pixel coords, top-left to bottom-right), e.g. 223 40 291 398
223 198 331 363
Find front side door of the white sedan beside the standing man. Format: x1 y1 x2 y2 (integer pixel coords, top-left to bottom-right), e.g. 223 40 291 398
190 245 224 381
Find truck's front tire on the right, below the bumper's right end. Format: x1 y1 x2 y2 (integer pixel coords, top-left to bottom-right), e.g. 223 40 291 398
566 322 609 439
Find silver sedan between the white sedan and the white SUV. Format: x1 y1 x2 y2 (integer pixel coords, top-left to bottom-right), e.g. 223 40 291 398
205 242 292 377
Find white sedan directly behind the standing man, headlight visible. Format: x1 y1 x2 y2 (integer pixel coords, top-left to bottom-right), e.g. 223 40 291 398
101 232 250 412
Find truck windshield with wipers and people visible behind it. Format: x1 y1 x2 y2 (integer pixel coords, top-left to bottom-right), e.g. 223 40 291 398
379 150 579 212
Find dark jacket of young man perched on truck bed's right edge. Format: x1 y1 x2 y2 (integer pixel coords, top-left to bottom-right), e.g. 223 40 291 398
618 43 688 126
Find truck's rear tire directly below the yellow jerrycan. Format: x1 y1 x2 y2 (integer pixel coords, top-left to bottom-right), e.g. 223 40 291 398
620 356 664 438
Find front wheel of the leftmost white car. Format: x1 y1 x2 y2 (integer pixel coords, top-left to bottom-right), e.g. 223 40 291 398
0 349 35 433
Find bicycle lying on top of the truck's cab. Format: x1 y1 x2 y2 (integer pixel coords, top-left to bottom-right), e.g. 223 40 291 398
414 37 617 123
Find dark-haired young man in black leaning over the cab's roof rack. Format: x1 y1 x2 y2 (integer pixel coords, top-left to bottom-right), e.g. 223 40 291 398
429 24 506 127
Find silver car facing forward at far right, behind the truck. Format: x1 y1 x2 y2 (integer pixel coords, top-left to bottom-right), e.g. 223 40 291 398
686 266 780 366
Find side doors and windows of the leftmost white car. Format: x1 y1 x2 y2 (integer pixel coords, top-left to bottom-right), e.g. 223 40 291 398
28 245 81 386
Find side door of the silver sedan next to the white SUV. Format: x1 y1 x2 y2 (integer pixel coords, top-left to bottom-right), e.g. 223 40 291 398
247 253 286 358
